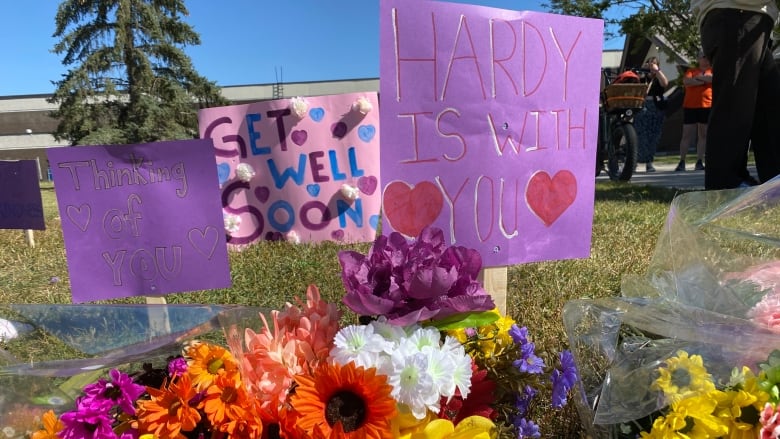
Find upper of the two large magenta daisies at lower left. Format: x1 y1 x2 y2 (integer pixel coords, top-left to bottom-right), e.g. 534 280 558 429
83 369 146 415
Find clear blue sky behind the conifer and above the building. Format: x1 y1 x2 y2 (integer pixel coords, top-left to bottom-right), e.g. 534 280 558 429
0 0 622 96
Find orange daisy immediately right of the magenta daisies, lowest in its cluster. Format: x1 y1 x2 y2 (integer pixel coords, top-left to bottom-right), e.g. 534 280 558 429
138 374 200 438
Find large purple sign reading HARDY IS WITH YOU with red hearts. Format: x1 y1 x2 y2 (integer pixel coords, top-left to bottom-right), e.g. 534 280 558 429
380 0 603 266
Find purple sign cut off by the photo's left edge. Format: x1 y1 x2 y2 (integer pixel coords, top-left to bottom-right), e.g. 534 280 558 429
0 160 46 230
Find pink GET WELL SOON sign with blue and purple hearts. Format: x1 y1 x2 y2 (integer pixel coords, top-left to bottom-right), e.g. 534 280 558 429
198 93 381 247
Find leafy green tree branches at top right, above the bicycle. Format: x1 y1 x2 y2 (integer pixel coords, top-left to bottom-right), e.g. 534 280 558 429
546 0 699 58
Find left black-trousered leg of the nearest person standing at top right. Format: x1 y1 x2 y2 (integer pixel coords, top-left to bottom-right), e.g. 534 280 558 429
701 9 765 189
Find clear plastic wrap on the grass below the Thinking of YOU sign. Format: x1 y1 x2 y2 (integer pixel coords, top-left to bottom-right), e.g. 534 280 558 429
0 305 264 437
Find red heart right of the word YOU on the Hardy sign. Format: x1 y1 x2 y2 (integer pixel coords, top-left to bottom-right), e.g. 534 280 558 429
525 170 577 227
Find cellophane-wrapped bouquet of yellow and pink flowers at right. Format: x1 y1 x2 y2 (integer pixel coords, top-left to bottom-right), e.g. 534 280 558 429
563 179 780 438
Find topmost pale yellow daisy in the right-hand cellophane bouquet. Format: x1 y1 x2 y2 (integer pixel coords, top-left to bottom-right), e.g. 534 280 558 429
651 350 715 403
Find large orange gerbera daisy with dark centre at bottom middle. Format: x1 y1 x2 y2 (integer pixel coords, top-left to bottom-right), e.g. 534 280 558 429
290 362 396 439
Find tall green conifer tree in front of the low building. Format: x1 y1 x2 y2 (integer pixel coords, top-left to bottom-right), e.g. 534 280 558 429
50 0 228 145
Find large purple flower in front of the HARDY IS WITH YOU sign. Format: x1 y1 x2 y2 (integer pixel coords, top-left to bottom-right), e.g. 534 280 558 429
339 227 495 325
